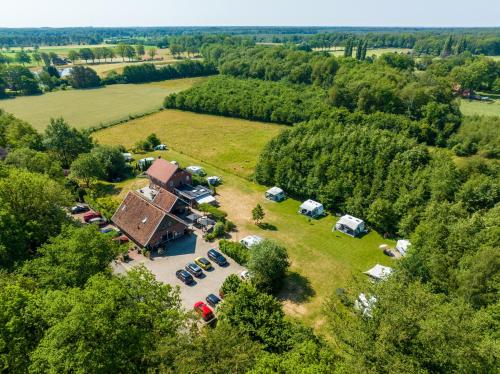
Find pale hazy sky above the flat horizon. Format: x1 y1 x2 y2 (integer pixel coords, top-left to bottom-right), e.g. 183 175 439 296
0 0 500 27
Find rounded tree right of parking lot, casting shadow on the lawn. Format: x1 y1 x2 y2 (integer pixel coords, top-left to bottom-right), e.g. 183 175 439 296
247 240 290 292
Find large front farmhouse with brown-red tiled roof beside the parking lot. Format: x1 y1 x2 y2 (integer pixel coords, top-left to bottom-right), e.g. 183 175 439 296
111 190 187 250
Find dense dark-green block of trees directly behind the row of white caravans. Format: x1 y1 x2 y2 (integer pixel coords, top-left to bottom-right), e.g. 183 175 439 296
255 118 500 236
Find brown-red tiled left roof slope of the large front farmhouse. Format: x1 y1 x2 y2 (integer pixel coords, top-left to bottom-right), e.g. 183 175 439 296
111 192 167 246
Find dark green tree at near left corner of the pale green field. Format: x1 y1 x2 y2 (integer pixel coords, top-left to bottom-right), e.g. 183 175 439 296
44 118 93 168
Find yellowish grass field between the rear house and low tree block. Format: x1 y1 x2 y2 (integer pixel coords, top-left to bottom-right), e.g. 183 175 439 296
94 109 286 178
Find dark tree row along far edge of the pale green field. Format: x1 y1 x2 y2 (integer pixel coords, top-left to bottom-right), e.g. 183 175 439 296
104 60 217 84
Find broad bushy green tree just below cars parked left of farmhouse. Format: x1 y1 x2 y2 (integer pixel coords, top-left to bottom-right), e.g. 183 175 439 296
22 225 120 289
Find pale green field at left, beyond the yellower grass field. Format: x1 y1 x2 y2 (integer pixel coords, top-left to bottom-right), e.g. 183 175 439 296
0 78 206 131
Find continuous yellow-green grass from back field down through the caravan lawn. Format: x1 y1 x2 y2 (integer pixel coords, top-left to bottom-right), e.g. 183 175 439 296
95 111 394 329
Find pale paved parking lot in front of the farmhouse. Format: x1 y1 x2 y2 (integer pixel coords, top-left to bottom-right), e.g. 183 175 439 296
115 232 244 309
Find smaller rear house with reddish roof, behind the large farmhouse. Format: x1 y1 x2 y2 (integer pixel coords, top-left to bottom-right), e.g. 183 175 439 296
147 158 192 192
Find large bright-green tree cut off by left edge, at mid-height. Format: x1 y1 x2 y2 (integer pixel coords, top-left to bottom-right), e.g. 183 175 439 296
0 169 70 267
